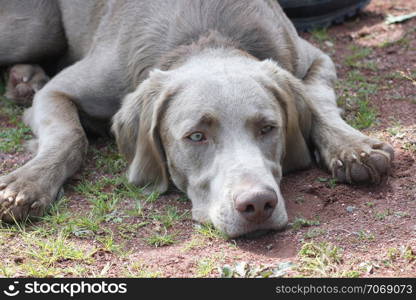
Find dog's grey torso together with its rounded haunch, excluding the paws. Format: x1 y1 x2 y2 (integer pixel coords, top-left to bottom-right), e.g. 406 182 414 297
0 0 298 87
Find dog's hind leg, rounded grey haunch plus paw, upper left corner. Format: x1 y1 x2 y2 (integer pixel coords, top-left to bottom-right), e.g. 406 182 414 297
0 0 66 105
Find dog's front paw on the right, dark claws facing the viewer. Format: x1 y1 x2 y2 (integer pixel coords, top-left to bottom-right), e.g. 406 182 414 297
329 137 394 184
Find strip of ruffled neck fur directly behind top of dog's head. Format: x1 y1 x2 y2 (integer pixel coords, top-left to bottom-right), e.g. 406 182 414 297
156 31 257 71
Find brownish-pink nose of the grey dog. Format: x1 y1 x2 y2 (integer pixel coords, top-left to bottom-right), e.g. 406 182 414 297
235 190 278 223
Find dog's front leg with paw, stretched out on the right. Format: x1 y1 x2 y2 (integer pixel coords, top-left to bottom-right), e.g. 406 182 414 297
302 40 394 183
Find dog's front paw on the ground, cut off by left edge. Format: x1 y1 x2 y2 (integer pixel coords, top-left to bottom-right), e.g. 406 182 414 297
0 167 52 222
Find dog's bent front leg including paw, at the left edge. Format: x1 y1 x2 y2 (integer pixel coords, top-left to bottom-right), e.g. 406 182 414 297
0 75 88 221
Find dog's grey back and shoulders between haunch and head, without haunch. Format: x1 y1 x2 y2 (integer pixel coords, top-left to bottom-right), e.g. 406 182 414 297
60 0 297 86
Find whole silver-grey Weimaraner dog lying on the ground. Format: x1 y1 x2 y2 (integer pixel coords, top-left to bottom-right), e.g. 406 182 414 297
0 0 394 237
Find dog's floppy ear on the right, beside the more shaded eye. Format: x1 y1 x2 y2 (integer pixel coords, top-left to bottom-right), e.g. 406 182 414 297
261 60 311 172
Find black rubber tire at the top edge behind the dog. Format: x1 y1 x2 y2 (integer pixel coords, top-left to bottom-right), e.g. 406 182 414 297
278 0 371 31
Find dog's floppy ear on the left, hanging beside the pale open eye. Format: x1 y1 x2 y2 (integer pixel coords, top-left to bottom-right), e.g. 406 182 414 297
112 70 172 192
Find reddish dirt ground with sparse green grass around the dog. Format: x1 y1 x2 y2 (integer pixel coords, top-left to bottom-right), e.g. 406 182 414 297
0 0 416 277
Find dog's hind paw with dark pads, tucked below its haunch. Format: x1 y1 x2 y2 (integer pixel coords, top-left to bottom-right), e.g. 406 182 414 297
5 65 49 105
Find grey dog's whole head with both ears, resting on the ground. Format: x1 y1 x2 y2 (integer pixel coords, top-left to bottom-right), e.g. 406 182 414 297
113 55 306 237
